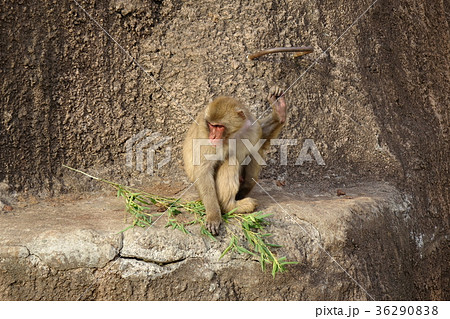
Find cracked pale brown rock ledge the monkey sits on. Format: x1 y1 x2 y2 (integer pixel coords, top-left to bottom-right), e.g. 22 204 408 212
0 181 411 300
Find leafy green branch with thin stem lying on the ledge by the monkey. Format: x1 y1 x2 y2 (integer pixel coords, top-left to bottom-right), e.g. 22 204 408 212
64 166 297 277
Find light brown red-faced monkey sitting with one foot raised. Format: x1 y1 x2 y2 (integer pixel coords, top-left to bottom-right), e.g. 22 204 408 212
183 87 286 235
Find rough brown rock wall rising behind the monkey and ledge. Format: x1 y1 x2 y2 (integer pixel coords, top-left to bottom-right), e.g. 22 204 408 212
0 0 450 299
